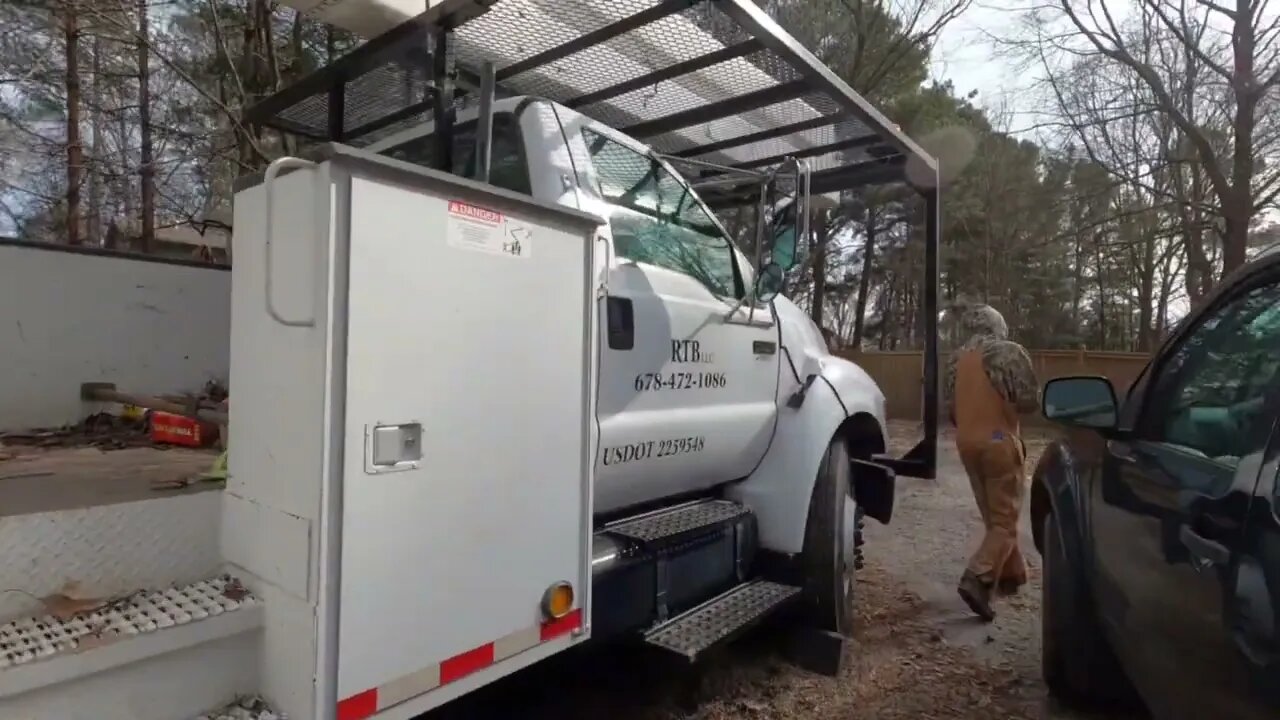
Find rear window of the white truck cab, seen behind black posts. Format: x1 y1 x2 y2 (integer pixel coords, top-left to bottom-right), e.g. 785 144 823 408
383 113 534 195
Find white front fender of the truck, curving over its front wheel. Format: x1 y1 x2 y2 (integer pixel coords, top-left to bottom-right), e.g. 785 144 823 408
726 299 886 555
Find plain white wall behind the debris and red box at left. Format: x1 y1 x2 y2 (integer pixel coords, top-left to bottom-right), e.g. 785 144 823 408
0 242 232 430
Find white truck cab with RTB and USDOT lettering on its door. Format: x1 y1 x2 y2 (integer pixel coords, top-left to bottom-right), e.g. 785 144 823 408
369 97 884 516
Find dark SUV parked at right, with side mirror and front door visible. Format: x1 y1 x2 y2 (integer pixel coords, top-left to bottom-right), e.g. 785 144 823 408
1030 254 1280 720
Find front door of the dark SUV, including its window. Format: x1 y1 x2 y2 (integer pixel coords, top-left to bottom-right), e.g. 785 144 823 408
1092 271 1280 720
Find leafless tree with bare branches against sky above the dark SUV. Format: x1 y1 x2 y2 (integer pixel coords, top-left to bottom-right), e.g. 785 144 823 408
1024 0 1280 281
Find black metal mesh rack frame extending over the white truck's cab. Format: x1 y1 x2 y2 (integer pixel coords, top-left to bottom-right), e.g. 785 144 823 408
246 0 940 477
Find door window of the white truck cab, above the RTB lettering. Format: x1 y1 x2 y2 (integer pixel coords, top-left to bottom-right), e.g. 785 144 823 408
582 129 742 299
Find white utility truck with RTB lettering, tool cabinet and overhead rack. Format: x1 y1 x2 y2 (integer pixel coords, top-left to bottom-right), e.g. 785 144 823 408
0 0 937 720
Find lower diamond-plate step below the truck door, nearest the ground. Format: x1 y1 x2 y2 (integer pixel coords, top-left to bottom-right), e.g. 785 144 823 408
644 580 800 661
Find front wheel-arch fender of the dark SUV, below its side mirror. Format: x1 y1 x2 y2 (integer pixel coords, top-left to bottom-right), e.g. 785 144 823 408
1030 439 1087 574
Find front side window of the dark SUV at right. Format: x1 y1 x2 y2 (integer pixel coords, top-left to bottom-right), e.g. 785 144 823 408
1143 282 1280 468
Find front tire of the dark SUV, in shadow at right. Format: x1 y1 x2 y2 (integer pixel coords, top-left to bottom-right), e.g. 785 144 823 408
1041 512 1137 710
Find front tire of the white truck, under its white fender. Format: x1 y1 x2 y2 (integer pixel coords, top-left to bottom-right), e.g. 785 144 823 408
801 437 861 637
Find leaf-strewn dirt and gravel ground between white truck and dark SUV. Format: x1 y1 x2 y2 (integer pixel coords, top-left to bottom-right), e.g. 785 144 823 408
420 423 1146 720
